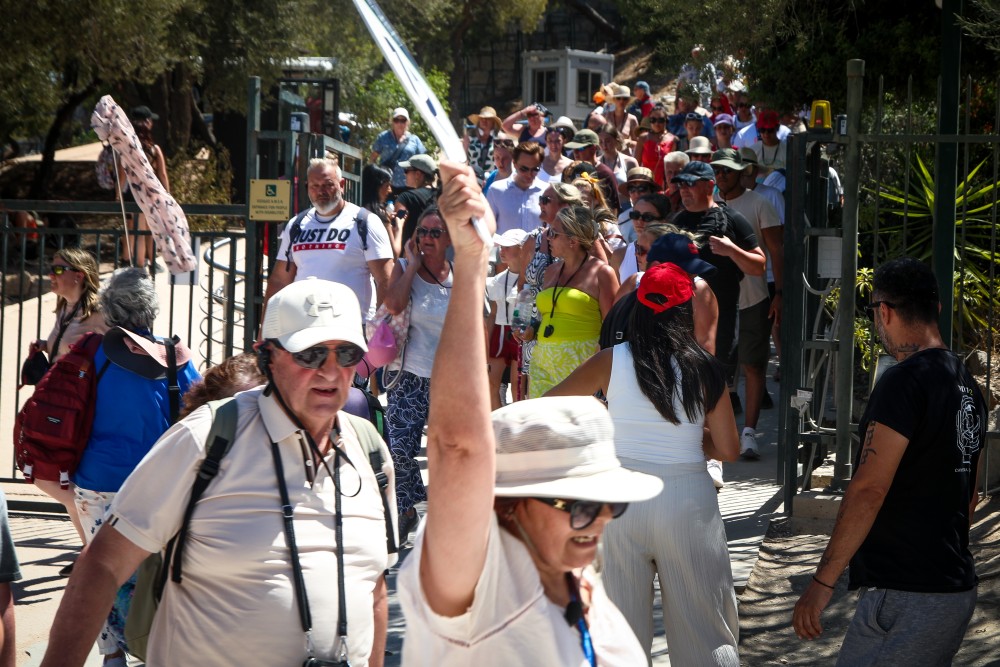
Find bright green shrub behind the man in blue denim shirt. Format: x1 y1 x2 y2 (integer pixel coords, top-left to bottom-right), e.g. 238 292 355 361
346 70 450 157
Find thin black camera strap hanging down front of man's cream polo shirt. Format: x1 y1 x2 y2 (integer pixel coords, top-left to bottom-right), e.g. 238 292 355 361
271 429 348 665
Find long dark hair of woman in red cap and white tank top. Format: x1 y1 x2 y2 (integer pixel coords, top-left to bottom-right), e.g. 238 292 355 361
629 301 726 424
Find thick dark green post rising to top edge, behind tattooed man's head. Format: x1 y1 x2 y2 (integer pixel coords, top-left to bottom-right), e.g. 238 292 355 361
931 0 964 347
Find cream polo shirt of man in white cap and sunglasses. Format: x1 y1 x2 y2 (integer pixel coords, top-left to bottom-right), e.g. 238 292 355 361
108 388 396 667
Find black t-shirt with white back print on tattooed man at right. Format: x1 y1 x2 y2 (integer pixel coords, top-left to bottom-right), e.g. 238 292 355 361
850 349 986 593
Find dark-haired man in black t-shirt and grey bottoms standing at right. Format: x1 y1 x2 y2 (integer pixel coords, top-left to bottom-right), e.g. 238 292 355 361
792 258 986 665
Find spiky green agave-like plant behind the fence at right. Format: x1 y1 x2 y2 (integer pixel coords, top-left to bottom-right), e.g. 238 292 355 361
877 155 1000 348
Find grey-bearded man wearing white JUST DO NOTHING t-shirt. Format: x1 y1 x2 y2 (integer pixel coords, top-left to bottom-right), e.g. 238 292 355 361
264 158 392 317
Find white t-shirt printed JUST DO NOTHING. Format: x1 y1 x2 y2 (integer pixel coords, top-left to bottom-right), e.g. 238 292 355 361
278 202 392 316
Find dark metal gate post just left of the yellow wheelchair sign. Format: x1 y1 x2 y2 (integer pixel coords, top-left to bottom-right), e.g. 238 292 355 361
241 76 264 350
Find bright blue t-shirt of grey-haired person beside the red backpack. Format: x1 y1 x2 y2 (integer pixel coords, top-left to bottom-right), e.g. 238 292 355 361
73 348 201 493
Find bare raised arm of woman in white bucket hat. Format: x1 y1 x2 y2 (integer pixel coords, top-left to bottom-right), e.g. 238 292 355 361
420 161 496 616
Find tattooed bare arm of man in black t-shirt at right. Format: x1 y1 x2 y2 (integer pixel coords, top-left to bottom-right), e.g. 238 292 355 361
792 422 909 639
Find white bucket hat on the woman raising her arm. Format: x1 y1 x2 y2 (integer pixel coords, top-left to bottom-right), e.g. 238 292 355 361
493 396 663 503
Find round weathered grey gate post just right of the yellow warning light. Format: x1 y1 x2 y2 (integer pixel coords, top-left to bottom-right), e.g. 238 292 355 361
833 60 865 485
